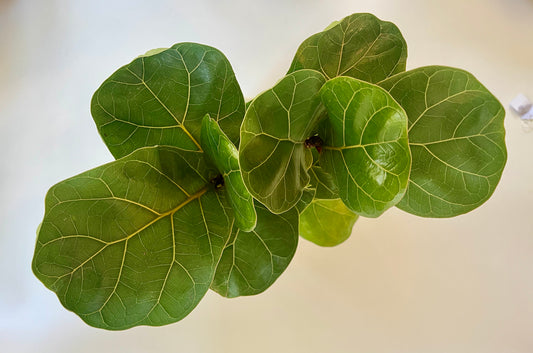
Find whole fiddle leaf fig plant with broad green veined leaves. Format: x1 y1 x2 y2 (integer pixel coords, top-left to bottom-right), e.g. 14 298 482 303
32 14 507 330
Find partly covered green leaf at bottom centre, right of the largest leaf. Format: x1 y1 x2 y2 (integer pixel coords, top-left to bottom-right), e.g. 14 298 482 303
211 204 298 298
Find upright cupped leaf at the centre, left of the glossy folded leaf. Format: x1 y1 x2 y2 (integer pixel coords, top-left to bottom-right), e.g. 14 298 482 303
239 70 325 214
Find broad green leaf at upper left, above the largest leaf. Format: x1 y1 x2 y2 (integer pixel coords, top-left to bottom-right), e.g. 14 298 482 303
91 43 245 158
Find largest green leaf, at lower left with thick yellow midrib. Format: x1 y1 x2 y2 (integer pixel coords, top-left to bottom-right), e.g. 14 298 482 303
32 147 232 330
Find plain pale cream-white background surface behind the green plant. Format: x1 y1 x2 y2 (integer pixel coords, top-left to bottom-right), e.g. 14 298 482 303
0 0 533 353
